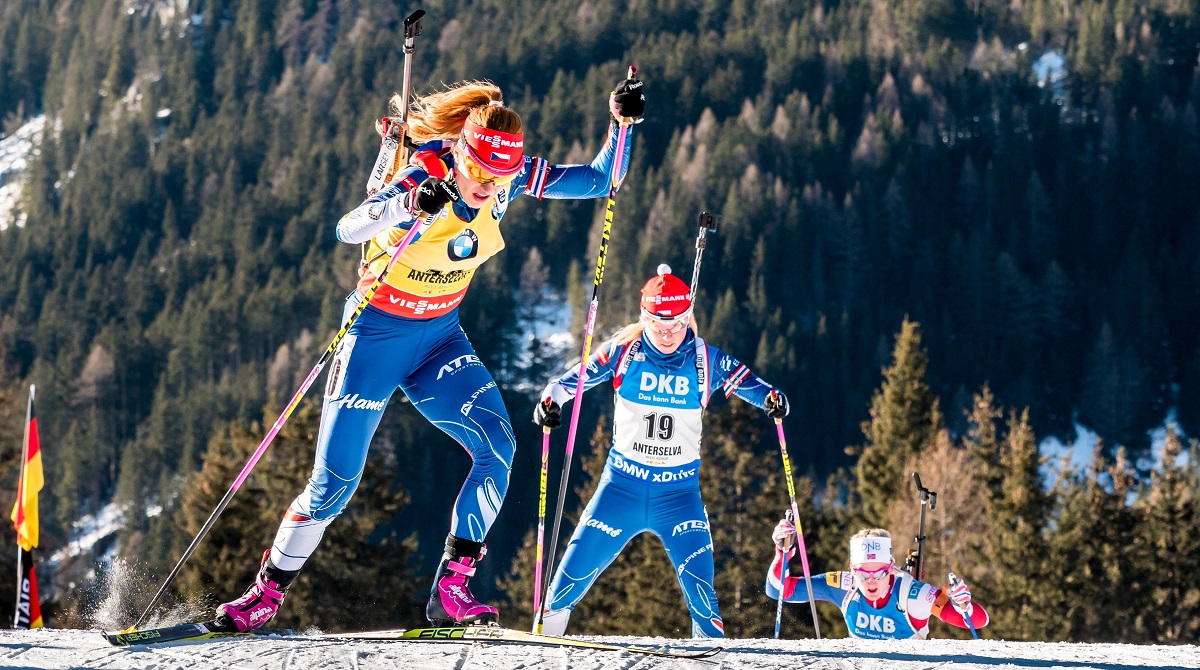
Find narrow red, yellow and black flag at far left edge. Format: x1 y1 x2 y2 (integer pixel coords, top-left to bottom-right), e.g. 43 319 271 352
12 387 43 628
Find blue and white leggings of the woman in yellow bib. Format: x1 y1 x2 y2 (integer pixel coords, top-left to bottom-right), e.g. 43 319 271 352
271 293 515 570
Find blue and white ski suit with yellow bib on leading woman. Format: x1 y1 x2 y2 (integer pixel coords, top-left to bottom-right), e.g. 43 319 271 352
271 125 631 570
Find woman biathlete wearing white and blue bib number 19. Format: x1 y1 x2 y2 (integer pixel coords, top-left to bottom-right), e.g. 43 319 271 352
534 265 787 638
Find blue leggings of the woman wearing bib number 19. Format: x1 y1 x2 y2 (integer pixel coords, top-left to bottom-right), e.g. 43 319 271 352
544 466 725 638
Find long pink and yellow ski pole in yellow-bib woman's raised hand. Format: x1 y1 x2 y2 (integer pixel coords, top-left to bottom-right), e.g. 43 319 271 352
534 65 637 628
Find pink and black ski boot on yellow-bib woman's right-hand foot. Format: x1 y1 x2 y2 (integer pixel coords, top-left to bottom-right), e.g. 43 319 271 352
425 534 500 628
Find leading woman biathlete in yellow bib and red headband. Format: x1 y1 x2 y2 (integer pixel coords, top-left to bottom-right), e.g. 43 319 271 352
217 79 644 630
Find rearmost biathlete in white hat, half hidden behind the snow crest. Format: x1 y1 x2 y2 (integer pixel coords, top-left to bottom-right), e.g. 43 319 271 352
767 519 988 640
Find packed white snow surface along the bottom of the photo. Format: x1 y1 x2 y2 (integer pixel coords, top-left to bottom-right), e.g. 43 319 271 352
0 630 1200 670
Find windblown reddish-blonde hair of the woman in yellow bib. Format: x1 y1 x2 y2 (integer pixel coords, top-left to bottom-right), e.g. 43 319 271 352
389 82 522 144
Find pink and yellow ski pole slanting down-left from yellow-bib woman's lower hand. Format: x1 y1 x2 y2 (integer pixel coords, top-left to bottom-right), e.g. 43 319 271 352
122 204 446 633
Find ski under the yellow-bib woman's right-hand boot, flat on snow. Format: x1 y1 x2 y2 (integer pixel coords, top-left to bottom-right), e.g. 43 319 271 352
318 626 724 660
